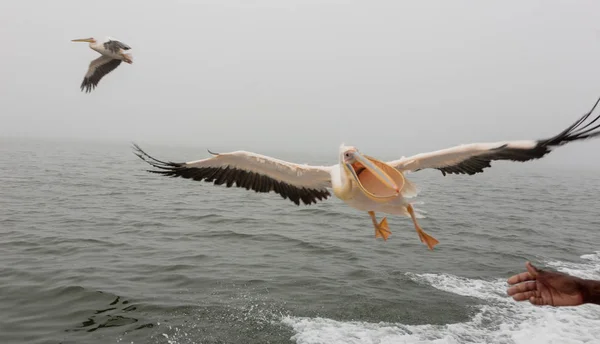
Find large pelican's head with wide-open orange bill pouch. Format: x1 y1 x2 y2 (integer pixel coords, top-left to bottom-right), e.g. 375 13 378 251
340 145 404 202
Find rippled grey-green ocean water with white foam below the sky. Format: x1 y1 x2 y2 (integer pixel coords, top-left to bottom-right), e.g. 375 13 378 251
0 139 600 344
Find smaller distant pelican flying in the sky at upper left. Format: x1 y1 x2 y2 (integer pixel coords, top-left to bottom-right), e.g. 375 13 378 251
71 37 133 93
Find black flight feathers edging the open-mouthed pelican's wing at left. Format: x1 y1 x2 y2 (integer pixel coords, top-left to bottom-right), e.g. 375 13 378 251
132 143 331 206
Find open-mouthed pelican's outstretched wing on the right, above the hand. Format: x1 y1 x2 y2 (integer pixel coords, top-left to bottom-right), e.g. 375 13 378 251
388 99 600 176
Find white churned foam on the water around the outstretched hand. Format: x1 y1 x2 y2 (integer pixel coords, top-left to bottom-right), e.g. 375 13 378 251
282 252 600 344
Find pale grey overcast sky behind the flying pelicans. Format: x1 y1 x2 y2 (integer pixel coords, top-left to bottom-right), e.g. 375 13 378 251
0 0 600 164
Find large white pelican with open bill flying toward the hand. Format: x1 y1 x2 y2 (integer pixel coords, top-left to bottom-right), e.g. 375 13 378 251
134 99 600 250
